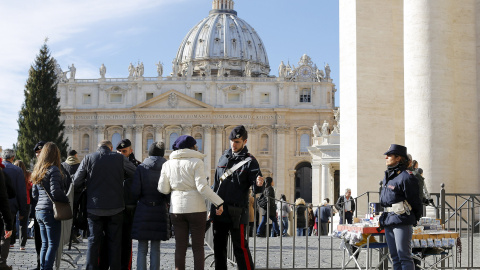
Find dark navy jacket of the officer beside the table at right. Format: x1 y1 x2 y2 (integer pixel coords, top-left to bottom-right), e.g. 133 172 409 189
380 166 423 226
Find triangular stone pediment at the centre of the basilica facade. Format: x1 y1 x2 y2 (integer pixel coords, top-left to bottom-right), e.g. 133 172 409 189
132 90 213 110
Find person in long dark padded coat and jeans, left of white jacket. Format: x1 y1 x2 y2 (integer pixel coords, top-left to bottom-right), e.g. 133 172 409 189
132 142 169 270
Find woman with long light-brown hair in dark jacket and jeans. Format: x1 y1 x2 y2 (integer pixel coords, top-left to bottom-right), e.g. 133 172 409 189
32 142 68 270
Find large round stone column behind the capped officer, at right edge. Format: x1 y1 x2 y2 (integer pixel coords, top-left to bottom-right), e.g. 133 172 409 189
404 0 480 193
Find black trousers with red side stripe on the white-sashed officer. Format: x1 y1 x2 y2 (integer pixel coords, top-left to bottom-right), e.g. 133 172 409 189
213 221 255 270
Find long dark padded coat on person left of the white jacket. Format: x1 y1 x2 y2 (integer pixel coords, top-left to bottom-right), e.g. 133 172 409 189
132 156 169 241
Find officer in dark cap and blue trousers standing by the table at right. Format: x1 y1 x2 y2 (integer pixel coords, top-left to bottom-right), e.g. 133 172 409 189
380 144 422 270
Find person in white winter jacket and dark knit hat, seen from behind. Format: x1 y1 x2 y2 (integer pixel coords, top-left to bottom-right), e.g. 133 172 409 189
158 135 223 270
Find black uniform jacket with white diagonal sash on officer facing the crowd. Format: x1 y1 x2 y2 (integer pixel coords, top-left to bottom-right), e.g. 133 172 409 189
210 146 263 224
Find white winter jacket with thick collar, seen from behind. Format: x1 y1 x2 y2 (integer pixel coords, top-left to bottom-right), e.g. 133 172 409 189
158 149 223 214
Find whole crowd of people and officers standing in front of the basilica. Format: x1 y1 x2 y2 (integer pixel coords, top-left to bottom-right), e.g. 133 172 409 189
0 137 428 270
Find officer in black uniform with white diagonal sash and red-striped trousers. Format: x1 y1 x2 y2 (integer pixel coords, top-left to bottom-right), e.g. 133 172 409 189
210 126 264 269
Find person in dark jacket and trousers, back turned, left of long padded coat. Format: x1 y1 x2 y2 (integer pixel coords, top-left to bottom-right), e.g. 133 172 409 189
73 140 136 270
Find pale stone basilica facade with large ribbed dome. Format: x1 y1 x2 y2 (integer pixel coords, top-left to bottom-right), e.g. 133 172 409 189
58 0 338 201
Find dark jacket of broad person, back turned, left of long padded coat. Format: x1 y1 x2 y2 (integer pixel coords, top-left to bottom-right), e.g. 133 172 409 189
73 146 135 209
